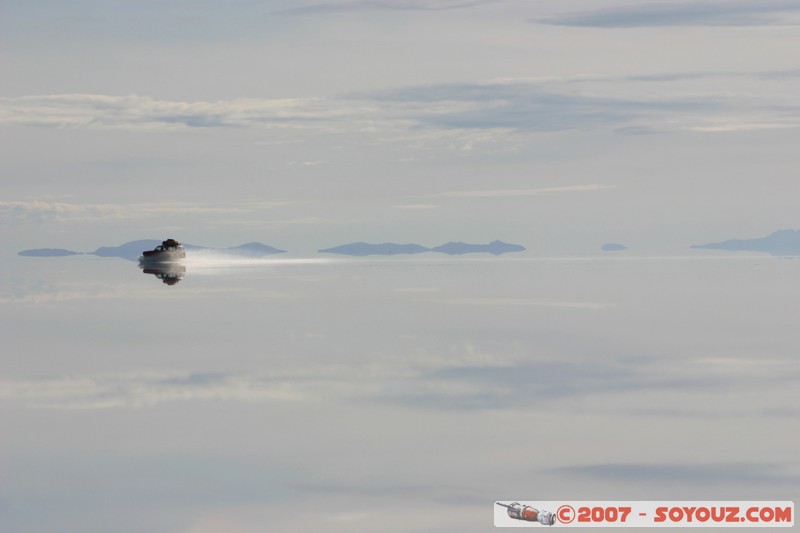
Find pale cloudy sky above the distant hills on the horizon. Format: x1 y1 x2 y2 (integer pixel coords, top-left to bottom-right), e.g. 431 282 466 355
0 0 800 255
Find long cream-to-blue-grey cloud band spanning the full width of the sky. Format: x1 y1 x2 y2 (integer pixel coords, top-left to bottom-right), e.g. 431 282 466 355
0 75 800 139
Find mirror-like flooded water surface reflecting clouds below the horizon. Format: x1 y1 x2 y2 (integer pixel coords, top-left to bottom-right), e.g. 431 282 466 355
0 254 800 533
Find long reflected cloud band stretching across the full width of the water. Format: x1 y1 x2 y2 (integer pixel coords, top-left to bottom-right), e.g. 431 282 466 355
0 354 797 412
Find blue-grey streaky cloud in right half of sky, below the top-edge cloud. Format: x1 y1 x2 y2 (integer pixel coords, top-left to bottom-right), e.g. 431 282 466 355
360 80 800 135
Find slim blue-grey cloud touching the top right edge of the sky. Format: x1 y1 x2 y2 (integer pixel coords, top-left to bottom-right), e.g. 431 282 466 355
532 0 800 28
